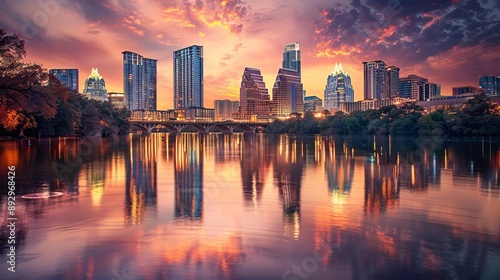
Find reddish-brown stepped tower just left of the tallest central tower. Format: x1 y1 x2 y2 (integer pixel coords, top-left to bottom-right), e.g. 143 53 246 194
240 67 271 116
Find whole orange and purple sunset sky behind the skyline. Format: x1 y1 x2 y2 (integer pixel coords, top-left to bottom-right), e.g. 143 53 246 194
0 0 500 110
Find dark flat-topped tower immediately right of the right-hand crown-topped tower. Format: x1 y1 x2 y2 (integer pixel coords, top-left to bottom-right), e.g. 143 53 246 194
363 60 388 100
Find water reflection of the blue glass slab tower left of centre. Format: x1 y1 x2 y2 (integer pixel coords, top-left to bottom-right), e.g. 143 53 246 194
174 134 205 220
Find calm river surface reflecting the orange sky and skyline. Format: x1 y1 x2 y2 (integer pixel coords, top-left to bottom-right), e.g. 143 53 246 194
0 133 500 280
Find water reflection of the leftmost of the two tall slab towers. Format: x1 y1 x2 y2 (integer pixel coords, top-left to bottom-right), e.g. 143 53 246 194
125 135 157 224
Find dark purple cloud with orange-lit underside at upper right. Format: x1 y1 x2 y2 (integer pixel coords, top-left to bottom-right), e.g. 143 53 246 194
314 0 500 66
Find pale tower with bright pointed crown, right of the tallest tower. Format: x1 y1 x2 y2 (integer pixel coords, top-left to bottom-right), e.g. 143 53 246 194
324 63 354 110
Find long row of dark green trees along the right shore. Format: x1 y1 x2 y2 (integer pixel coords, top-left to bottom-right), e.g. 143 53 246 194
266 94 500 136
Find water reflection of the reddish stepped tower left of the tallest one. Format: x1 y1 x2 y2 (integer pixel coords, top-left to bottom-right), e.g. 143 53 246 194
241 134 270 207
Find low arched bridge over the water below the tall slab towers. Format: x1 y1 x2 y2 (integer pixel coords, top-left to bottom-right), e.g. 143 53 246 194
130 118 268 133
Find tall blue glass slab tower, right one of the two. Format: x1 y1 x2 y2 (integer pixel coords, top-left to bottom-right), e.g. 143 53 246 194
174 45 203 109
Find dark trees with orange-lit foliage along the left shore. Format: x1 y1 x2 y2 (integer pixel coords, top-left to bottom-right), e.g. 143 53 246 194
0 29 130 136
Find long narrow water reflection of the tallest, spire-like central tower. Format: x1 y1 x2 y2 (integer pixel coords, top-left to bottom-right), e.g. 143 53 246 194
273 136 304 239
